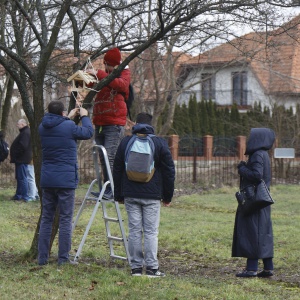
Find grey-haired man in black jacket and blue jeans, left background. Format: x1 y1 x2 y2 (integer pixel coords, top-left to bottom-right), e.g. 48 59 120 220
10 119 35 202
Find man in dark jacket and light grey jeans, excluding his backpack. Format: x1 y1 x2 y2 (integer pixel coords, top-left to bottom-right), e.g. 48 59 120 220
113 113 175 277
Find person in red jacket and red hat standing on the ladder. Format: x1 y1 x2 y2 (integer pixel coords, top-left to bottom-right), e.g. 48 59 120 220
87 48 130 198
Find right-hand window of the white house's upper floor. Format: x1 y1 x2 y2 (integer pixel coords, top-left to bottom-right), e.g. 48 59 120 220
232 72 248 105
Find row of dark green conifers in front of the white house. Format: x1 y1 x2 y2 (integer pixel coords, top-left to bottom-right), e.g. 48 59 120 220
172 97 300 155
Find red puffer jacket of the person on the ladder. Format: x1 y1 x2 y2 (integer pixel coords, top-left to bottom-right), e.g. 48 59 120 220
93 69 130 126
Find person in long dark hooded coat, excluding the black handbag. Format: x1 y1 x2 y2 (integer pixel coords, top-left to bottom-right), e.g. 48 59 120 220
232 128 275 277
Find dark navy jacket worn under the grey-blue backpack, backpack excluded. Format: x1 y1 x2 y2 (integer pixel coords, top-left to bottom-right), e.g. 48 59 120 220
113 123 175 203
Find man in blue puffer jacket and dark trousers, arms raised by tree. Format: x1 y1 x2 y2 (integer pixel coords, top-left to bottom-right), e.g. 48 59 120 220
38 101 94 265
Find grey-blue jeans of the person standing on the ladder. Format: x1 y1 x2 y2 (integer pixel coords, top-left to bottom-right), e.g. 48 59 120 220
95 125 125 182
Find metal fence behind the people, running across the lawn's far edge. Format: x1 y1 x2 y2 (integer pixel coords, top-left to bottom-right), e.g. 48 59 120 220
0 137 300 190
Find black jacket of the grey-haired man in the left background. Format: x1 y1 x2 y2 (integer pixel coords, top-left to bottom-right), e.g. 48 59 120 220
10 126 32 165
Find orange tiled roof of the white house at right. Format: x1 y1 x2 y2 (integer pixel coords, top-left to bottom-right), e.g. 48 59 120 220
185 15 300 94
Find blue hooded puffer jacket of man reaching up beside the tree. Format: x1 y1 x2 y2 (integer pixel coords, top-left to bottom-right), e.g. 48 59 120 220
39 113 94 189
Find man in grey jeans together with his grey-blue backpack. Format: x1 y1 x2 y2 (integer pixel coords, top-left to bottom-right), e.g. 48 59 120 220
113 113 175 277
